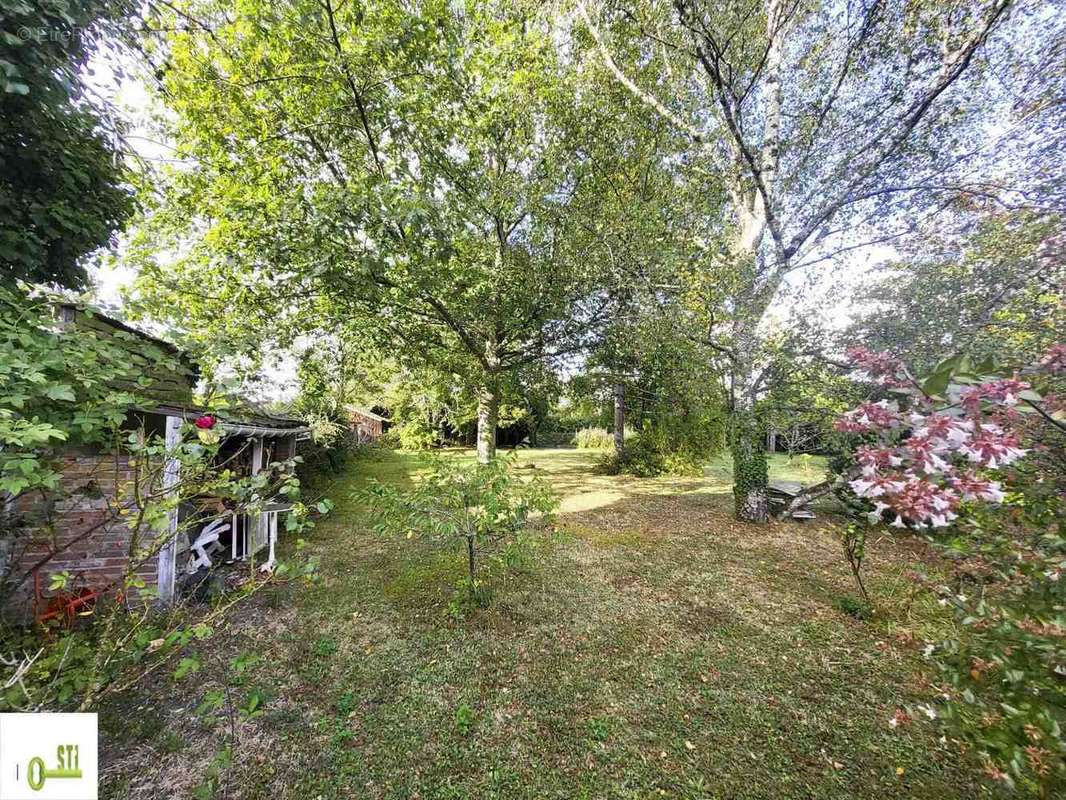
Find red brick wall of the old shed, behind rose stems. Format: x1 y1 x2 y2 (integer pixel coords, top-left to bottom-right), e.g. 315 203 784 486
6 451 158 610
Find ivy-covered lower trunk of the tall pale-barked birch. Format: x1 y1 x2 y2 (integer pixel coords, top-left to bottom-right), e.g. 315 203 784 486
730 319 770 523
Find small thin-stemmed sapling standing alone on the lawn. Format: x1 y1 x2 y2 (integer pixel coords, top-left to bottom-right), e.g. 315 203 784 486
357 459 558 598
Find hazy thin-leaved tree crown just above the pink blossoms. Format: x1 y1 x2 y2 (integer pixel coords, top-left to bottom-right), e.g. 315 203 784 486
844 213 1066 373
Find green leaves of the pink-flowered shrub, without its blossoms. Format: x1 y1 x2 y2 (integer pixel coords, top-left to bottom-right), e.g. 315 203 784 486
831 351 1066 797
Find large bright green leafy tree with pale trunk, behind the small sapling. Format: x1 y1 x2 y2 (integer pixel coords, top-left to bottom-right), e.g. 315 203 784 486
131 0 611 461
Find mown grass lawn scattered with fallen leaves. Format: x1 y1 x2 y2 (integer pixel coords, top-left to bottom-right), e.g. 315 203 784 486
101 450 988 800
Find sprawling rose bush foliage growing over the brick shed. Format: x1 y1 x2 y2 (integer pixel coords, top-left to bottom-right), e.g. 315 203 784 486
0 287 328 710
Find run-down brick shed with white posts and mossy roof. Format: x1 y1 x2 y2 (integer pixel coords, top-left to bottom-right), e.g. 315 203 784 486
0 304 309 619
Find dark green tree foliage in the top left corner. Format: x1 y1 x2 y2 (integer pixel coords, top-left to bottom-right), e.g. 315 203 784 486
0 0 134 289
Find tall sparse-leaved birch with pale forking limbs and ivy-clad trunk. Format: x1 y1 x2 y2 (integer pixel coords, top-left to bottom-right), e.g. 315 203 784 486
578 0 1063 521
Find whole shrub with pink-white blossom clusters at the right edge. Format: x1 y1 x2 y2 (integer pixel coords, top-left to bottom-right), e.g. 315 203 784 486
836 346 1066 797
